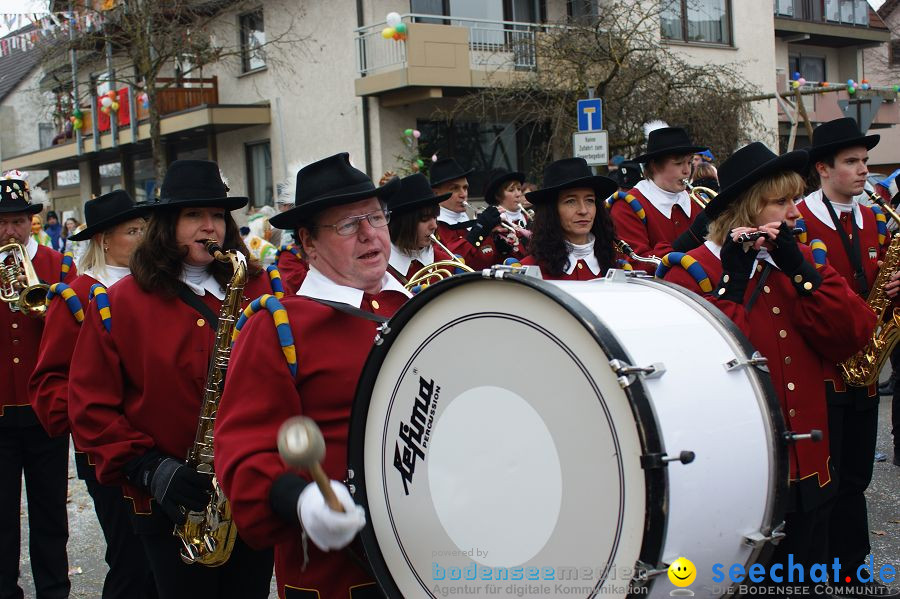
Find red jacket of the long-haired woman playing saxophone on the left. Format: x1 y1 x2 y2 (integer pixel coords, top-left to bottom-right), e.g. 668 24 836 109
69 273 272 514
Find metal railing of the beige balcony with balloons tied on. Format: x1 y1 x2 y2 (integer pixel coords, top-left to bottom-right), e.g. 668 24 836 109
355 13 556 76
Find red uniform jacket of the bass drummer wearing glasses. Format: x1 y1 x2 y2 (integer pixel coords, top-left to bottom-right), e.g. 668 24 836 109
215 291 407 599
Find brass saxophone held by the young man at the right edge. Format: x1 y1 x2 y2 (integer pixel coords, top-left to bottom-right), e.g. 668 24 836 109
839 194 900 387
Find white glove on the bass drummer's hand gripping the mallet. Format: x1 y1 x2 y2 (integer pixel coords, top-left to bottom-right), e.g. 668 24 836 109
297 480 366 551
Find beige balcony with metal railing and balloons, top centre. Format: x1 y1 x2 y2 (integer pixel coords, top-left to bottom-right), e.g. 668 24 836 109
355 14 552 106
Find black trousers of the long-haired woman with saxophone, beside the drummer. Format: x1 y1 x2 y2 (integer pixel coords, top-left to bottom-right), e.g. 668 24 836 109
138 529 274 599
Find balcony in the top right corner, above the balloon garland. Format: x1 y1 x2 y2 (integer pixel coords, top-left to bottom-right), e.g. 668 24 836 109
774 0 890 48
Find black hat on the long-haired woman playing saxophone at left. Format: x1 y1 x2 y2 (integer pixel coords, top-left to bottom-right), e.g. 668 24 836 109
153 160 249 210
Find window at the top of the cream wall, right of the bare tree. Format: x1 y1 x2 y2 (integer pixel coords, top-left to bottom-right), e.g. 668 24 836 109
660 0 731 44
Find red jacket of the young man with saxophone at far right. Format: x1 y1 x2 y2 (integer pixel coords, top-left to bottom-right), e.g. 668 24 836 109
797 196 889 401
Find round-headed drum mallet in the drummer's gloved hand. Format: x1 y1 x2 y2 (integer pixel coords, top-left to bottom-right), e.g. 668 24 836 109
278 416 344 512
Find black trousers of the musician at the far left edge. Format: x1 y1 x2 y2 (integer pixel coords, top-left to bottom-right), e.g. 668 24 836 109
0 425 70 599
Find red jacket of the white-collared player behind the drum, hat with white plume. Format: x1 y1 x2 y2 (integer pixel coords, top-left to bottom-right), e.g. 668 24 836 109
610 188 701 275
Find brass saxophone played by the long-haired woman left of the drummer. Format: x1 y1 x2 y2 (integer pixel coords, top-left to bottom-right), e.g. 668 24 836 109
174 239 247 566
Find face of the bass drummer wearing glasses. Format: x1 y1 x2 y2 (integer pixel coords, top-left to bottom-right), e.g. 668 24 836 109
299 198 391 293
